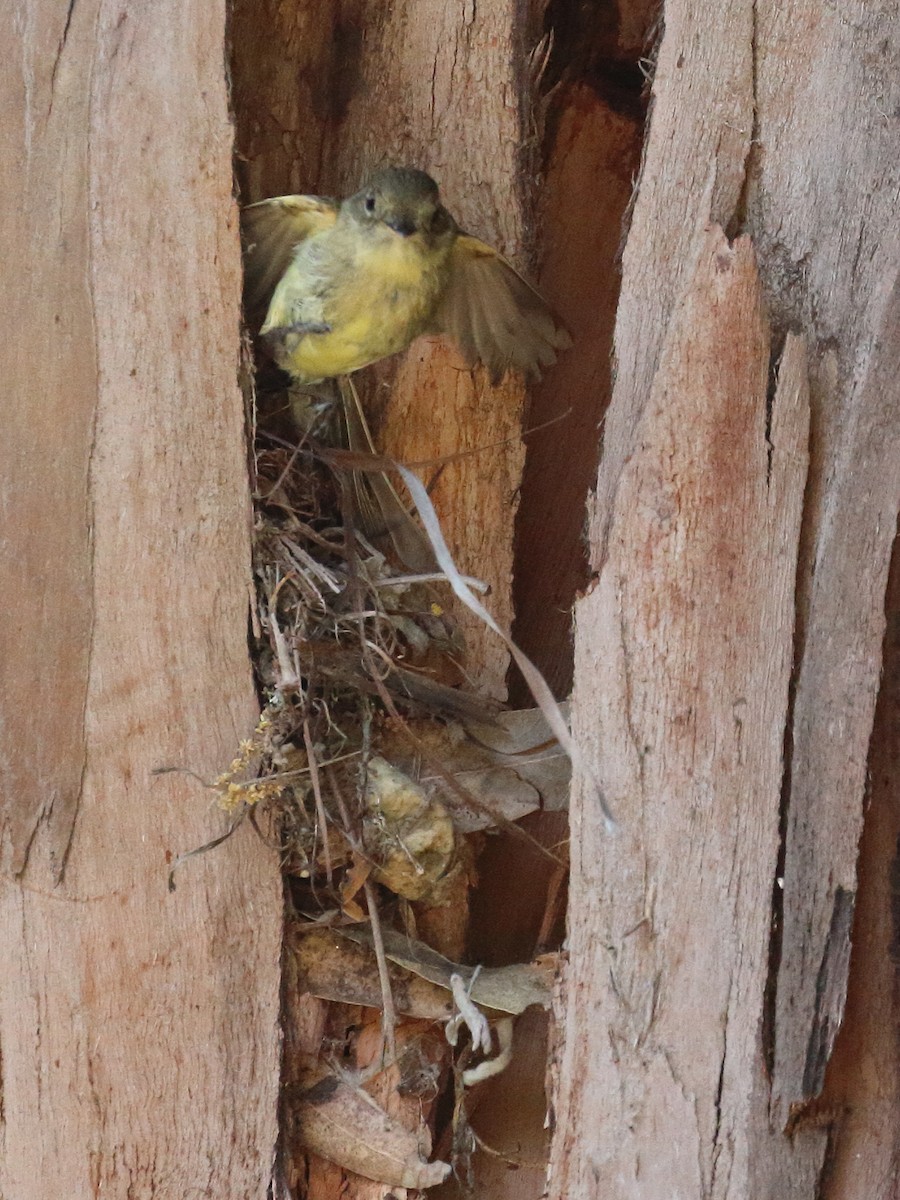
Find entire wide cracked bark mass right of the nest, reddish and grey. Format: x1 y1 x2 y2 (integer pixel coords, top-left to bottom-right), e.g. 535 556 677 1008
551 0 900 1200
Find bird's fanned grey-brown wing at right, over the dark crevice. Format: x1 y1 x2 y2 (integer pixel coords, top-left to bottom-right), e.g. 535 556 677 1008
434 234 571 383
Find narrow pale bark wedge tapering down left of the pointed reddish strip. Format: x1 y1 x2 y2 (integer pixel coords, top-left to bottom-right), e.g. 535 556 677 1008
590 0 754 552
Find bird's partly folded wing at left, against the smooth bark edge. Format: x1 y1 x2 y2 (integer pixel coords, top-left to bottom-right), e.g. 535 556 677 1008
241 196 338 324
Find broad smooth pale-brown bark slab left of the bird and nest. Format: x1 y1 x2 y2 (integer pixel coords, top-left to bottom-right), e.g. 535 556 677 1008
0 0 281 1200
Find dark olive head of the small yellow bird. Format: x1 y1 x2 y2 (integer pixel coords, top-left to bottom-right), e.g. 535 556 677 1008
342 167 457 246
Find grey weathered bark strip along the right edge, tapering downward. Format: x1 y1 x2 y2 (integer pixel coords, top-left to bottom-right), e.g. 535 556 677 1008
749 0 900 1121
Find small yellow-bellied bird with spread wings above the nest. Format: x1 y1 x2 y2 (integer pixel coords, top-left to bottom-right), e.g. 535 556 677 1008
244 167 571 385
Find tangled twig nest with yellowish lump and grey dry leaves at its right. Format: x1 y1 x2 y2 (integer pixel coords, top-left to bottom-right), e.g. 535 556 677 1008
204 386 568 919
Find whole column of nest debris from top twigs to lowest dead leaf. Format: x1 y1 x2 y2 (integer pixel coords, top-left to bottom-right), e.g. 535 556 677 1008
166 357 569 1187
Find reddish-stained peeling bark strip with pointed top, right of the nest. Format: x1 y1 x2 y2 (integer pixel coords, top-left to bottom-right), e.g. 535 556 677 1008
551 227 809 1200
